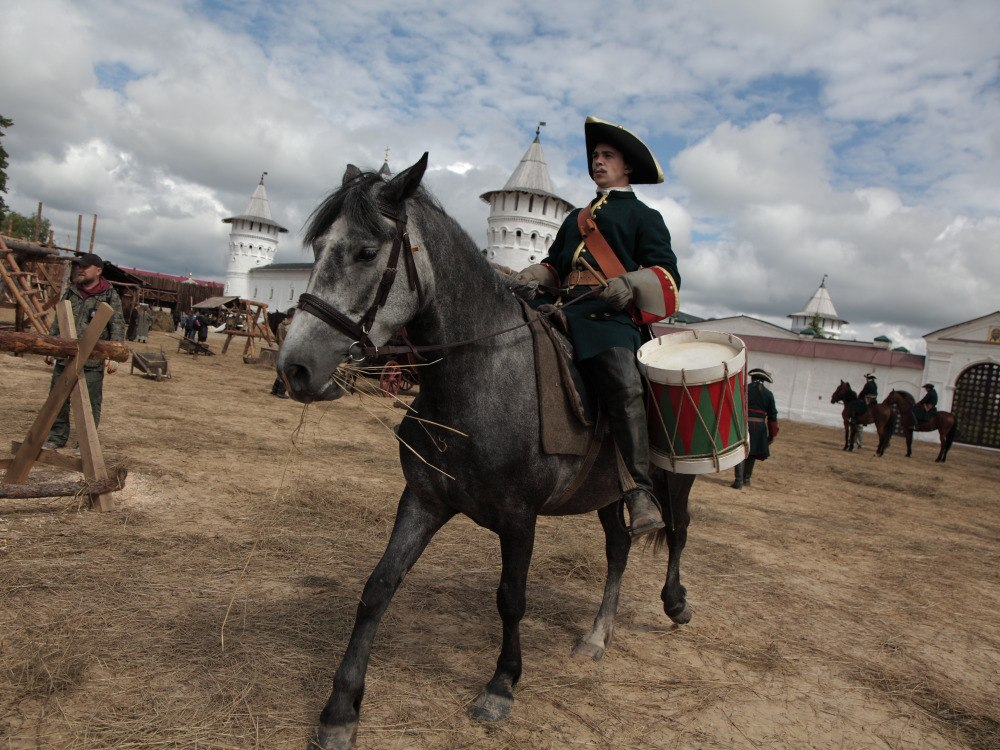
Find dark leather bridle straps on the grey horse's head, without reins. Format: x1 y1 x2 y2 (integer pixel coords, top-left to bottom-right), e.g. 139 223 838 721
299 204 424 362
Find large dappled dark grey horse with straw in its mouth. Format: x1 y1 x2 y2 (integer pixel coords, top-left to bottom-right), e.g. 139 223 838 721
278 154 694 750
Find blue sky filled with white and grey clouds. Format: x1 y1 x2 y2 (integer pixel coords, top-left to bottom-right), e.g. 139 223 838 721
0 0 1000 352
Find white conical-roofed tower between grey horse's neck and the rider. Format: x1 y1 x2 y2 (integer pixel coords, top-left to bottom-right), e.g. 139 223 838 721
479 122 573 271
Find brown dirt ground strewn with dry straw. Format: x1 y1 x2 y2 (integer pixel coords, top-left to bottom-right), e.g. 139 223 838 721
0 333 1000 750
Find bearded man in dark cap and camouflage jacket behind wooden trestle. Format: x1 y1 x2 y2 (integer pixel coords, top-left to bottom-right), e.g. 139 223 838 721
44 253 125 450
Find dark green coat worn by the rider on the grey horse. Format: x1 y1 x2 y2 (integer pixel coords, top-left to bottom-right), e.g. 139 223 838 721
540 190 681 361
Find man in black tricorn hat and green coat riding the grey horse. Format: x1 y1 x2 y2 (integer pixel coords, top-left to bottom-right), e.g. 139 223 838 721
516 117 681 537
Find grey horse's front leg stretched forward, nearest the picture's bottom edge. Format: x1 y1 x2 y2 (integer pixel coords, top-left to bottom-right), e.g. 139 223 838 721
309 487 454 750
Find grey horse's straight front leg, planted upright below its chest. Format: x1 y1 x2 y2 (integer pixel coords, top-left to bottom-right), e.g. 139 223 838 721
469 514 535 721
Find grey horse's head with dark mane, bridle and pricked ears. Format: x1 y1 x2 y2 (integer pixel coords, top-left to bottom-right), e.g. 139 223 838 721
277 153 433 402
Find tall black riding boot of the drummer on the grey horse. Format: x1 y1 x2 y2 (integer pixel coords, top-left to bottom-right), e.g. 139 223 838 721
581 347 664 538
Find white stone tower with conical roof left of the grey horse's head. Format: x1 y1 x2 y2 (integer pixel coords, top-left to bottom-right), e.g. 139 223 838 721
222 172 288 299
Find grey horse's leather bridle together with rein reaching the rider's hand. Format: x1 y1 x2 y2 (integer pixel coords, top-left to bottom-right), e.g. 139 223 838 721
298 206 598 362
